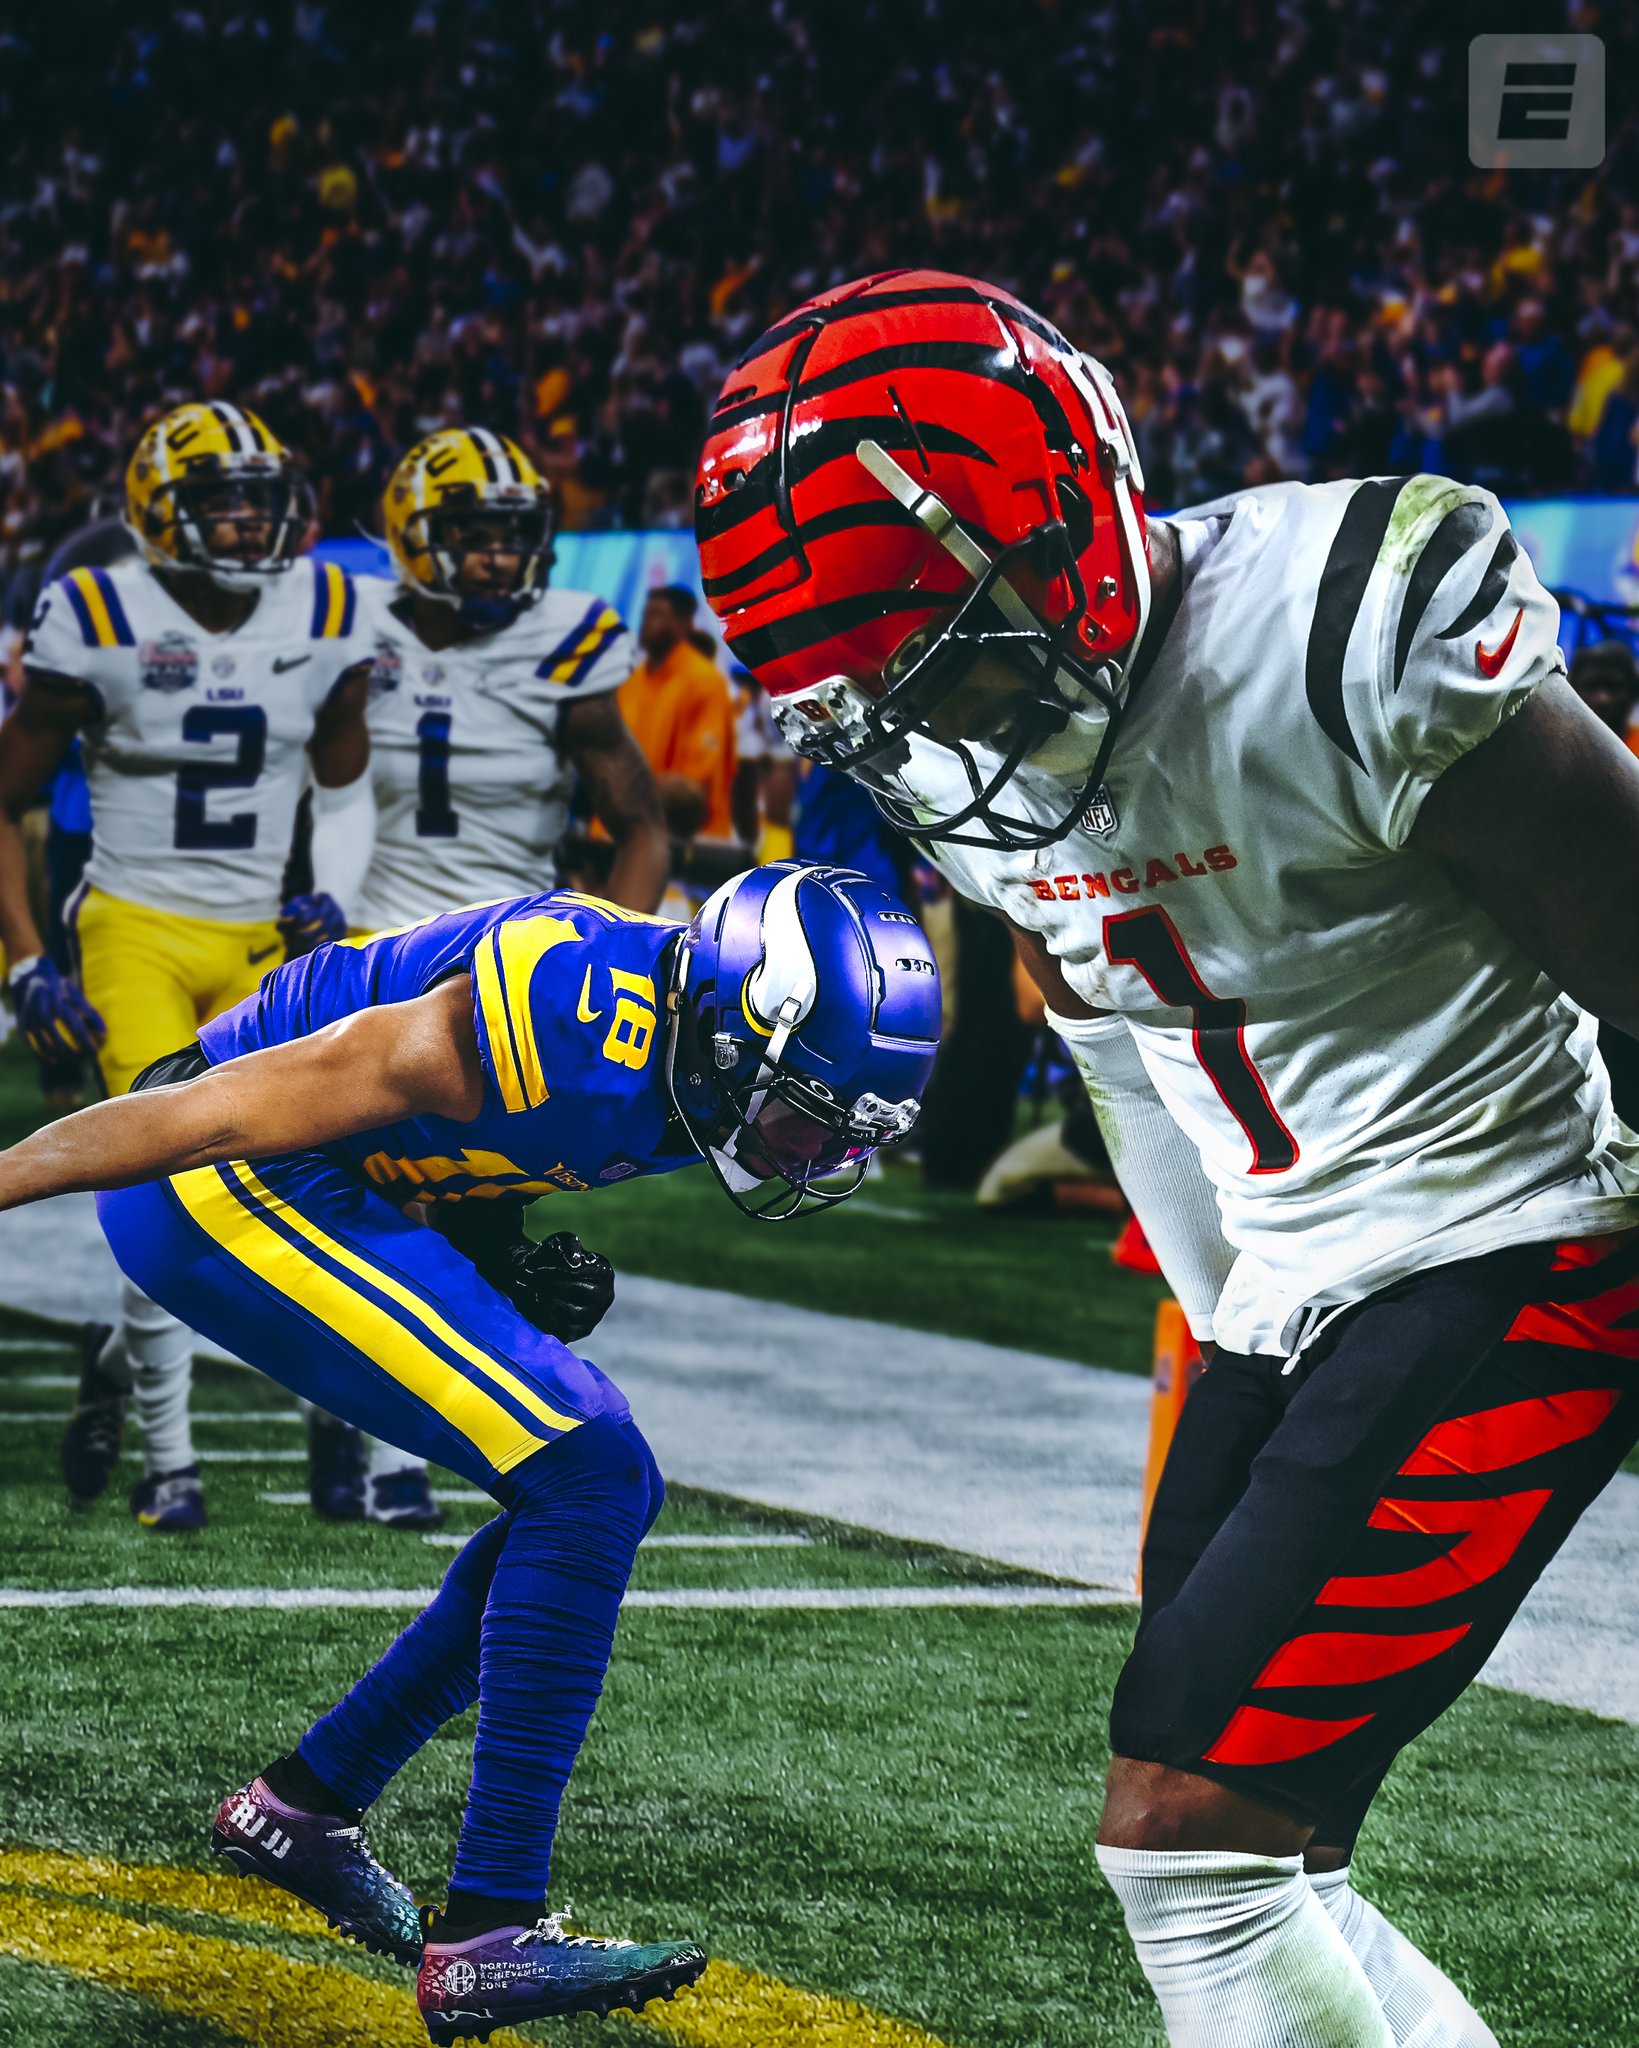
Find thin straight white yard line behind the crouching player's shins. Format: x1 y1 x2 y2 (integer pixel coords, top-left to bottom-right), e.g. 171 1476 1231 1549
0 1585 1129 1614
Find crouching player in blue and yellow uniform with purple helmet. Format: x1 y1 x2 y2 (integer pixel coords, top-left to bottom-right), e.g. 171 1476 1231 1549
0 862 938 2042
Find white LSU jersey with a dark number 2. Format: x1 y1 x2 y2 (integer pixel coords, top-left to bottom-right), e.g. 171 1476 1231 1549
23 557 369 924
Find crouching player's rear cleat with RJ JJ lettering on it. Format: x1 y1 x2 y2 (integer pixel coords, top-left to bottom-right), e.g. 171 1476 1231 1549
211 1778 422 1962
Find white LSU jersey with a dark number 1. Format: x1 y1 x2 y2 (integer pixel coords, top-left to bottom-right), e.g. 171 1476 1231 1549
348 580 633 932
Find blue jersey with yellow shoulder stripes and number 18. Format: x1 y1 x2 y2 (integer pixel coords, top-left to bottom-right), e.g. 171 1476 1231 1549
199 891 697 1202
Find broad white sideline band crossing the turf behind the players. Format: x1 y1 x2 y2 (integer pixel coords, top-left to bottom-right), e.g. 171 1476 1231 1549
0 1194 1639 1724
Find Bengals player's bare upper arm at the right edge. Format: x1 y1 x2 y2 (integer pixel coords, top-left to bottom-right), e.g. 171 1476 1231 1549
1407 676 1639 1036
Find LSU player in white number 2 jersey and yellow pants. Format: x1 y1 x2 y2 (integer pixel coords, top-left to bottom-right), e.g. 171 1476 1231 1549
0 403 369 1530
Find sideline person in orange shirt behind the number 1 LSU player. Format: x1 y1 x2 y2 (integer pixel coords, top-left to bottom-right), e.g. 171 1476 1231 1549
621 584 733 840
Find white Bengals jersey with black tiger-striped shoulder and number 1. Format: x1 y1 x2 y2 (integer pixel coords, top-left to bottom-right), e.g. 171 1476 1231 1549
918 477 1639 1352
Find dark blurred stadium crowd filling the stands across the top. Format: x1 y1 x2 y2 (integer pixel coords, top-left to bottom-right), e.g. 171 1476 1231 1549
0 0 1639 608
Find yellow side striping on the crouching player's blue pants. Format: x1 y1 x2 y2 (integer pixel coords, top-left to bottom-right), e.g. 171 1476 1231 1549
170 1161 576 1473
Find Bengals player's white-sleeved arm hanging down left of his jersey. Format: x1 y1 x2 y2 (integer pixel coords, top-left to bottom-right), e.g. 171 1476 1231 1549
1010 924 1235 1356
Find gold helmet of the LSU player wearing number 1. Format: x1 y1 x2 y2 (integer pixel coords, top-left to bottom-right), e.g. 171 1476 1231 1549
381 426 551 623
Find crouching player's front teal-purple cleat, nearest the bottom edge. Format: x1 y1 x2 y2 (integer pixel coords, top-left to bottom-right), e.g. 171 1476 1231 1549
416 1913 705 2048
